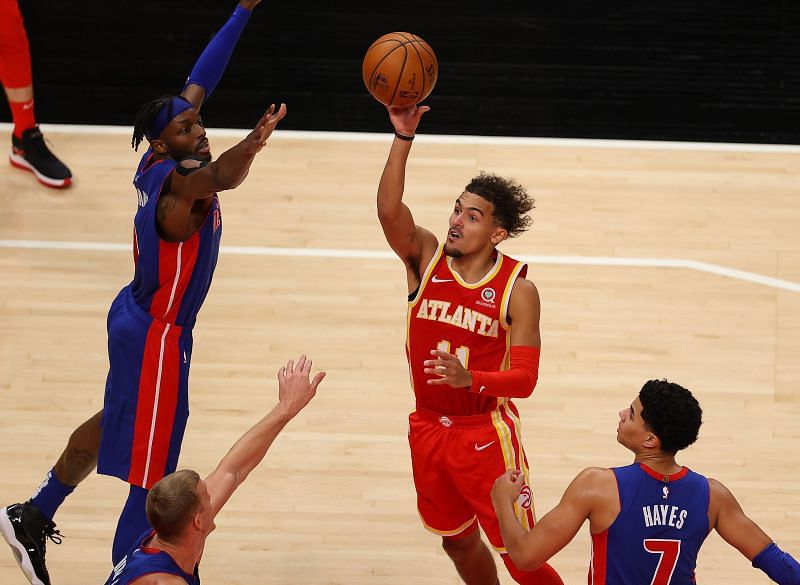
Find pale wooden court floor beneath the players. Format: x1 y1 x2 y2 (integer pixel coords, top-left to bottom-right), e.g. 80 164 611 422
0 125 800 585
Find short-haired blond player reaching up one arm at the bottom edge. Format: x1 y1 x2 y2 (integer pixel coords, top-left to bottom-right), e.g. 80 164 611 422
106 356 325 585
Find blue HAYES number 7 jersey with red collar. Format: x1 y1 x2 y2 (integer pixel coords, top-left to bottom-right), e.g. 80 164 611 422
589 463 709 585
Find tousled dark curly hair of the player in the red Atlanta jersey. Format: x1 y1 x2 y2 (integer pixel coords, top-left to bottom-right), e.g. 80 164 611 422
464 171 534 238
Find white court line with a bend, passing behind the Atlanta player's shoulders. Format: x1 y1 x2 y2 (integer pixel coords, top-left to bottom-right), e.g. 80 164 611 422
0 240 800 292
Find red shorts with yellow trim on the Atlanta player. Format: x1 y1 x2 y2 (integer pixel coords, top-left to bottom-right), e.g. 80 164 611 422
408 402 535 553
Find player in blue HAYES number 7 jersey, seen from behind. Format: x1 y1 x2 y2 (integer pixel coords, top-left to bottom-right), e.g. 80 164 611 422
492 380 800 585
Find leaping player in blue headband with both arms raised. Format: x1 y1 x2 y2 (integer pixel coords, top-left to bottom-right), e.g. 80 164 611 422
0 0 286 585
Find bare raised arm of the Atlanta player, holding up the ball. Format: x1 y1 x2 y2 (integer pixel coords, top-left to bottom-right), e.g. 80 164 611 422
378 106 437 285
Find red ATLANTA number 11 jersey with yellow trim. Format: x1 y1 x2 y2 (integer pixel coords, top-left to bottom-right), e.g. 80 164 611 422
406 245 528 416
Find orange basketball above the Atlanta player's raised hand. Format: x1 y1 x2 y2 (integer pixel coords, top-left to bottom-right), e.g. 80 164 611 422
361 32 439 108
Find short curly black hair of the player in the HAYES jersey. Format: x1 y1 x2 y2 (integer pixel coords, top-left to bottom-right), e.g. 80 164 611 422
639 380 703 454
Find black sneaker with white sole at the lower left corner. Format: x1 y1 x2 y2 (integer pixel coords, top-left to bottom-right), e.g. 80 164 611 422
0 502 61 585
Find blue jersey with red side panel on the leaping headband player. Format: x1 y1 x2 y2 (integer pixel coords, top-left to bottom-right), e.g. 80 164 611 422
129 149 222 328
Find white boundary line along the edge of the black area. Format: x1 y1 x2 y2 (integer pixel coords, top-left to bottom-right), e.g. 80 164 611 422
0 122 800 153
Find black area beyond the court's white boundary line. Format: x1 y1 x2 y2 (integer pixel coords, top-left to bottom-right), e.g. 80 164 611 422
6 0 800 144
